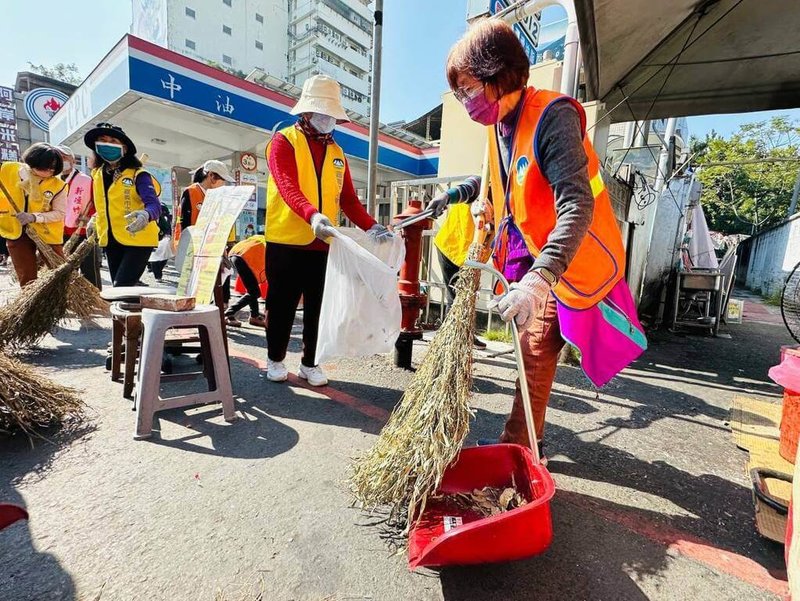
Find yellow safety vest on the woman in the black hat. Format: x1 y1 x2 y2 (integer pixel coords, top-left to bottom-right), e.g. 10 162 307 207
92 168 161 247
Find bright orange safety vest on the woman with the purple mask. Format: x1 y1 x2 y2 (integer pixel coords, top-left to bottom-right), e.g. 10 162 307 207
487 88 625 309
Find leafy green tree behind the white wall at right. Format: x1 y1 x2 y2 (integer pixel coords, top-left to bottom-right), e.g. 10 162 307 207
690 117 800 234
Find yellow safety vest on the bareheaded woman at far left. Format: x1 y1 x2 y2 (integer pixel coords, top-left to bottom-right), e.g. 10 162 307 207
0 162 66 244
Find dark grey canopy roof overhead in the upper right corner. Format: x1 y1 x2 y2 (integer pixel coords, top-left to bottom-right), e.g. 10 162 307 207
575 0 800 122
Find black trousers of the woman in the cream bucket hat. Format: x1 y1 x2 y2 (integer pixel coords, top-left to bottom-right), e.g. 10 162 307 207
266 243 328 367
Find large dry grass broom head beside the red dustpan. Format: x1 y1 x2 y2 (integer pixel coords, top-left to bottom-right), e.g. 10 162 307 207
350 244 485 522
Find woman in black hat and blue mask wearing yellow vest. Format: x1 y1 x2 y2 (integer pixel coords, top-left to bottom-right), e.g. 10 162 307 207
83 123 161 286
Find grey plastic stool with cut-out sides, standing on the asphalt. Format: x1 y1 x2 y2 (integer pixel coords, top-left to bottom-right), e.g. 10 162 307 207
134 305 236 439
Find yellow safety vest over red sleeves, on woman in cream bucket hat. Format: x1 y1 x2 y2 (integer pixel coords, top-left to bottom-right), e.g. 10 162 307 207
265 125 346 246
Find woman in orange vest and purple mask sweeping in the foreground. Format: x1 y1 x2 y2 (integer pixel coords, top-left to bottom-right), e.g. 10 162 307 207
447 20 643 460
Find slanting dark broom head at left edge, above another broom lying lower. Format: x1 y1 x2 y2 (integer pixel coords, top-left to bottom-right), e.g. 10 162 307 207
0 237 93 347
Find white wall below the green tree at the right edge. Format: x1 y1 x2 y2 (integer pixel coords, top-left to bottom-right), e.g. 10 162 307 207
739 214 800 296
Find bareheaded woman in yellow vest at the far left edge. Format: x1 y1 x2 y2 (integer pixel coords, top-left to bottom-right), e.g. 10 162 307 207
0 142 67 286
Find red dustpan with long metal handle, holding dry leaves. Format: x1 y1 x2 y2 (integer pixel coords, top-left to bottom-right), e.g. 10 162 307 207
408 261 555 570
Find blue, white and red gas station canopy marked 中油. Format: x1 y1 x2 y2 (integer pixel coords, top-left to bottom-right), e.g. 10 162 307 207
50 35 439 181
